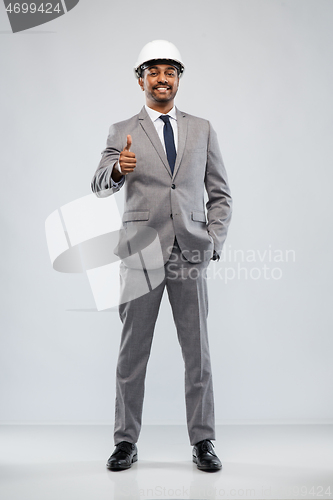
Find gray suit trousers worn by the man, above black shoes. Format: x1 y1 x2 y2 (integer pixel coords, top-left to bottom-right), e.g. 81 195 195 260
114 240 215 445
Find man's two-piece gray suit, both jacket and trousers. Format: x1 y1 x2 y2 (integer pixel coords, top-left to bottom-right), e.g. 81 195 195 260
91 107 231 444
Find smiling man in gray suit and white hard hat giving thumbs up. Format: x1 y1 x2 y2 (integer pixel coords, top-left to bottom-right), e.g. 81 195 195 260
92 40 231 471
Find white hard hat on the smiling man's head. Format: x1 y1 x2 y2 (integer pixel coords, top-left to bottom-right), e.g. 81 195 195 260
134 40 185 78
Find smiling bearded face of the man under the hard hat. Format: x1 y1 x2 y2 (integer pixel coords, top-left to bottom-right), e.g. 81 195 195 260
139 64 179 104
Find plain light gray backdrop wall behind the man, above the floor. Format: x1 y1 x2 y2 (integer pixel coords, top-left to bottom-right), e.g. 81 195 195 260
0 0 333 423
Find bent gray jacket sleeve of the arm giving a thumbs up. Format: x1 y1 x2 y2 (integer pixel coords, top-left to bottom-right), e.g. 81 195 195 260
91 125 126 198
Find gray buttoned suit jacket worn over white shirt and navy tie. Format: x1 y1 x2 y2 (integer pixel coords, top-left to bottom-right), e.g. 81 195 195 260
91 107 232 267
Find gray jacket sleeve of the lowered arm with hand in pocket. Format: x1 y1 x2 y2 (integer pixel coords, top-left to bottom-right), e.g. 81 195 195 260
205 123 232 257
